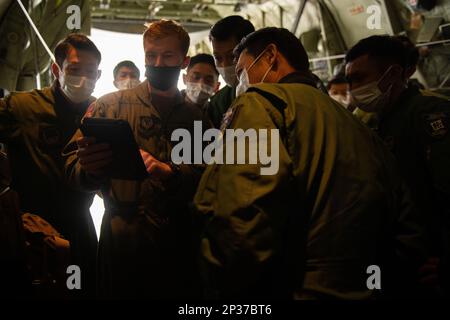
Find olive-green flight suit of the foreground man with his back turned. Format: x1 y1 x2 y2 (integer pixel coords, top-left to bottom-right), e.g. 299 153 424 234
194 73 424 299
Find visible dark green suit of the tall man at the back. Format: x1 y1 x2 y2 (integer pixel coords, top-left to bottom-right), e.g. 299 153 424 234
207 85 236 128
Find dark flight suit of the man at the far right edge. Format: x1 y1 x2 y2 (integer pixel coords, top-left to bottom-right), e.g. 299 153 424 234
377 87 450 289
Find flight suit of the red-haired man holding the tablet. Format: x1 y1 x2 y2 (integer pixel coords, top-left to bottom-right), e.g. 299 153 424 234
65 81 206 298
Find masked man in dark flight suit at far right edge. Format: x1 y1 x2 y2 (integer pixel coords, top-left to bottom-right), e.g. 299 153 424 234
346 36 450 296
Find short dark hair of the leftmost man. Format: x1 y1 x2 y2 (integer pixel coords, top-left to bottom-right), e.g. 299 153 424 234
55 33 102 68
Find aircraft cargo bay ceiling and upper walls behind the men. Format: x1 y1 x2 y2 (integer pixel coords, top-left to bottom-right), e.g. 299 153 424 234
0 0 450 90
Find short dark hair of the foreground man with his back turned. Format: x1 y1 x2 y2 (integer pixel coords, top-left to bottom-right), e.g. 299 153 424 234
234 27 309 71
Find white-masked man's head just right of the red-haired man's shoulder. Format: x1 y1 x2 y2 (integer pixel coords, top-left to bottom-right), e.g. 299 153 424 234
182 53 220 109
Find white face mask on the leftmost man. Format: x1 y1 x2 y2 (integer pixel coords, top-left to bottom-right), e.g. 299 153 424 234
59 72 97 103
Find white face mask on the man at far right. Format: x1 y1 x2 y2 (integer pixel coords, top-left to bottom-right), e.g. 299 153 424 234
350 67 392 112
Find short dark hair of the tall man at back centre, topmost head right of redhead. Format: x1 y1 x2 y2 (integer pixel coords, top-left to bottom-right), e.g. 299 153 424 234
209 16 255 42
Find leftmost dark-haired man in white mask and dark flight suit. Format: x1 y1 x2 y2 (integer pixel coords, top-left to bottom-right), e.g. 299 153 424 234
0 34 101 296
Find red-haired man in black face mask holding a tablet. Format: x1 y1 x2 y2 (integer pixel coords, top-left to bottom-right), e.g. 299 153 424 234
65 20 206 298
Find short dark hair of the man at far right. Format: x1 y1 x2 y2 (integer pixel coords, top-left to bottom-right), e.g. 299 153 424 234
345 35 407 69
